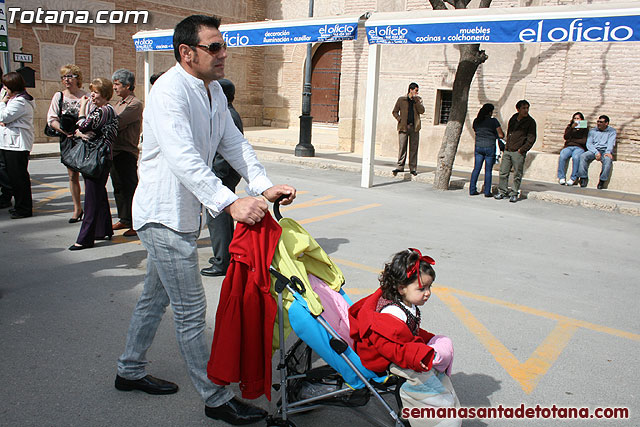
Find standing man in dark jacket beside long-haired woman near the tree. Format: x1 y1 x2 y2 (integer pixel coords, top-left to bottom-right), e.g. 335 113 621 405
496 99 536 203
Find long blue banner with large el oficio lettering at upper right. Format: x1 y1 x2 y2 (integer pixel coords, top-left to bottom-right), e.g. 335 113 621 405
366 16 640 44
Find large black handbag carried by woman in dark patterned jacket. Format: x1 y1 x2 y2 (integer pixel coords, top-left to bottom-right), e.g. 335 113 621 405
60 136 111 179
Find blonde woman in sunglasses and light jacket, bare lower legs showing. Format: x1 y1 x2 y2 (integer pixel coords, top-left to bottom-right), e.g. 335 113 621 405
47 64 88 223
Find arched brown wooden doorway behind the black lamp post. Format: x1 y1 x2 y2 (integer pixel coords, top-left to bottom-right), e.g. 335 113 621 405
311 42 342 123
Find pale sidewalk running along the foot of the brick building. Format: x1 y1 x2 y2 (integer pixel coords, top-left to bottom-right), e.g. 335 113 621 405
31 126 640 216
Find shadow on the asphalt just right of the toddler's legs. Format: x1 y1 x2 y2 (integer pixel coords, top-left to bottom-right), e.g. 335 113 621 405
451 372 500 427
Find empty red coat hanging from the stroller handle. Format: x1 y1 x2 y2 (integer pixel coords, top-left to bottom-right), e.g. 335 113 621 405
207 213 282 400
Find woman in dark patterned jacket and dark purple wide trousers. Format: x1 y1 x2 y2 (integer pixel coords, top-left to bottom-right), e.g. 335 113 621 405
69 77 118 251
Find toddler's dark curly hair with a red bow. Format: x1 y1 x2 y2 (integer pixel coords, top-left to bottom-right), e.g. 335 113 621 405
378 249 436 301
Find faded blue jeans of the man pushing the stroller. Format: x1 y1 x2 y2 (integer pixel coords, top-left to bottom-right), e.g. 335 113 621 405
118 223 233 406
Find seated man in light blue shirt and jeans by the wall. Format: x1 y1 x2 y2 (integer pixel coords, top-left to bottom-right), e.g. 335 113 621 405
578 115 616 190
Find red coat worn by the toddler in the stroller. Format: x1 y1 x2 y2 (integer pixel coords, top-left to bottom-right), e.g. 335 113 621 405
349 289 435 372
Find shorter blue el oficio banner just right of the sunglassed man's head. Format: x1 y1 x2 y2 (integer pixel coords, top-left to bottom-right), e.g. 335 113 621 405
220 21 358 47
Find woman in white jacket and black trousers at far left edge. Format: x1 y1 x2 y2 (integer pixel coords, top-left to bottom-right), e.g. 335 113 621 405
0 72 36 219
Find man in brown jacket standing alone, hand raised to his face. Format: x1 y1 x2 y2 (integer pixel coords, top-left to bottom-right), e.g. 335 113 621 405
391 83 424 176
